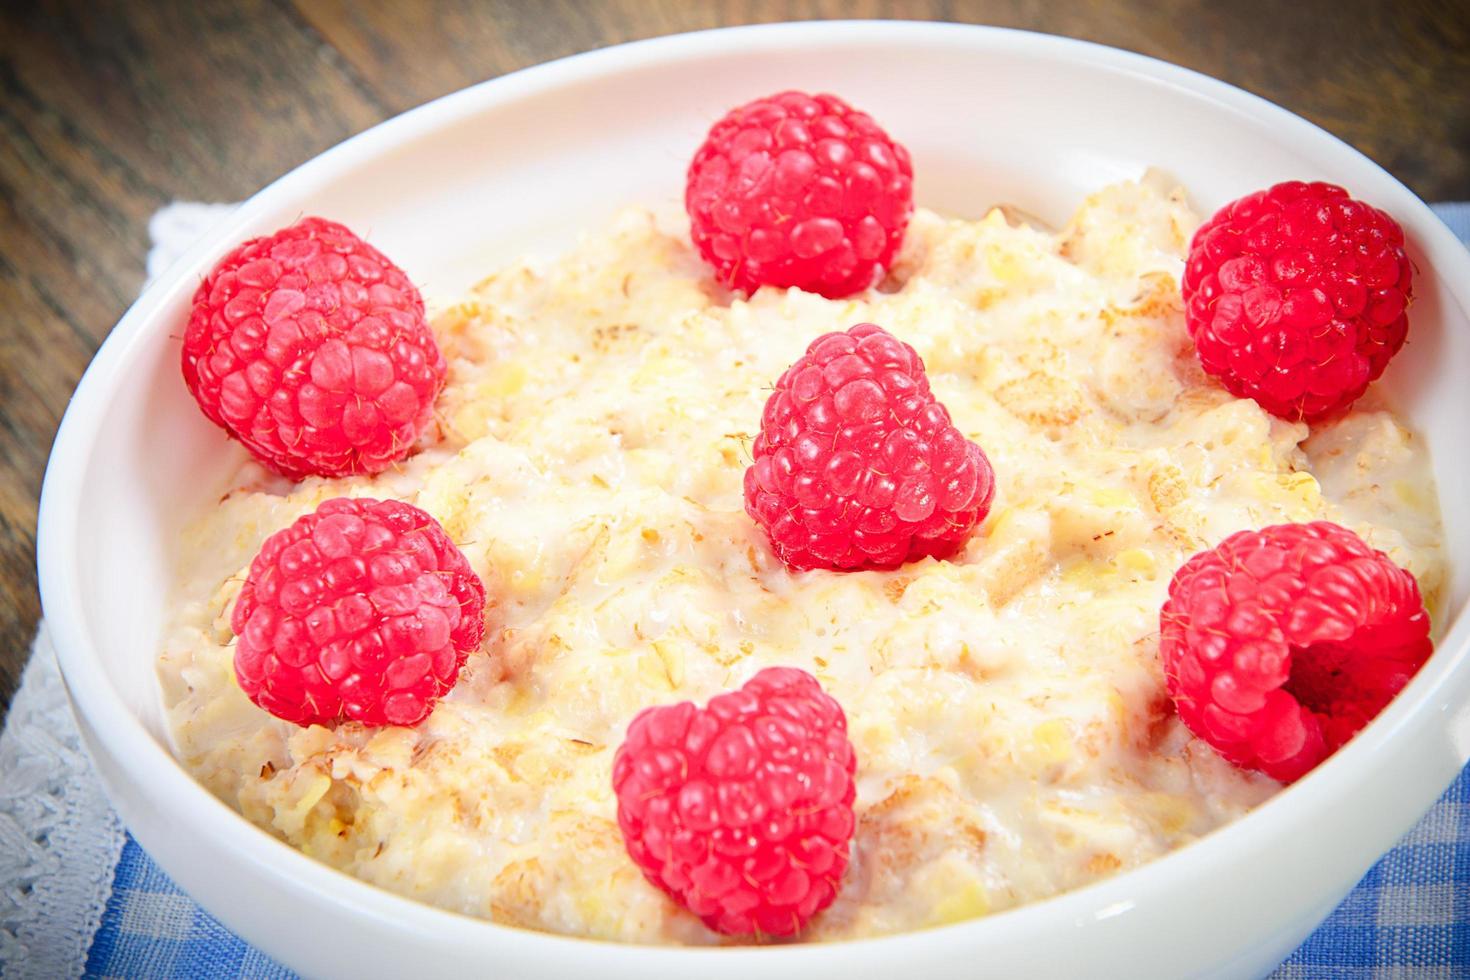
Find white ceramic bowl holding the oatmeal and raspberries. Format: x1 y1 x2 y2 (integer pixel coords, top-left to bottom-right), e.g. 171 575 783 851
40 17 1470 980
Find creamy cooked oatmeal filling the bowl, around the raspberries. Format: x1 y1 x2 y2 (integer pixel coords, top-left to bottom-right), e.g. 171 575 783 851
159 178 1444 943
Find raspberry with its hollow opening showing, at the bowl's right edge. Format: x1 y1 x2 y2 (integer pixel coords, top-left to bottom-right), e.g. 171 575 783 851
1158 522 1433 783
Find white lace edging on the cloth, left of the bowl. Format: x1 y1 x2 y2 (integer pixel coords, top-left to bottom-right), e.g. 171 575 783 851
0 203 234 980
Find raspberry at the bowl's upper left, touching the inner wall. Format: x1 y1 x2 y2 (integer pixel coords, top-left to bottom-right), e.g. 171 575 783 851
184 217 445 479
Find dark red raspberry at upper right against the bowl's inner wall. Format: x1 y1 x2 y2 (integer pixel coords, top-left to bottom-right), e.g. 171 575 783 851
1183 181 1414 422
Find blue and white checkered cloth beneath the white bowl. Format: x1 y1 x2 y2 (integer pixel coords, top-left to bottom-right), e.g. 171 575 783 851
77 203 1470 980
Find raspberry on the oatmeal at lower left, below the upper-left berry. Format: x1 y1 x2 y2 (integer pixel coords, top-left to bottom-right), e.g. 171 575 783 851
229 497 485 726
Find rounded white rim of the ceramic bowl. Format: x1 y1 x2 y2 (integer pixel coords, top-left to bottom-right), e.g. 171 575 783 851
37 21 1470 968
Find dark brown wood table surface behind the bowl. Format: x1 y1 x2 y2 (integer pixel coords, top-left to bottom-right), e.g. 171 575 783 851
0 0 1470 710
